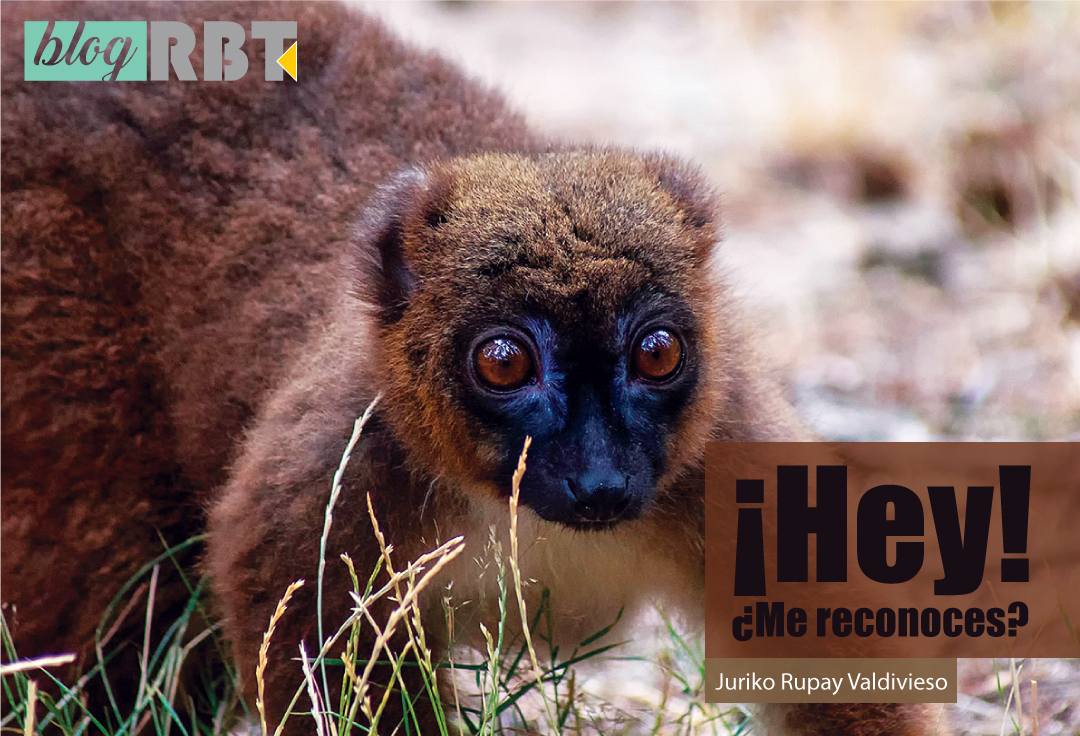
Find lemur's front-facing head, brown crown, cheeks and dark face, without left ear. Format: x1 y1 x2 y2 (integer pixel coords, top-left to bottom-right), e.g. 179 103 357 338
365 152 717 530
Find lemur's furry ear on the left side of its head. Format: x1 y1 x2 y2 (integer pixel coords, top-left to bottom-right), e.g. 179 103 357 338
355 169 447 324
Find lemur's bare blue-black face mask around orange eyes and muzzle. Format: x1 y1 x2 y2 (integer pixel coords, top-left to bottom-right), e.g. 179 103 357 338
457 287 701 528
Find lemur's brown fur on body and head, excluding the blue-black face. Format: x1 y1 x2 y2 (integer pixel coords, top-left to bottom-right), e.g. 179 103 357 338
2 3 940 736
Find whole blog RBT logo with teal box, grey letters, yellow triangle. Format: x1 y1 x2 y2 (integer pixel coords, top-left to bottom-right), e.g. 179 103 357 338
23 21 296 82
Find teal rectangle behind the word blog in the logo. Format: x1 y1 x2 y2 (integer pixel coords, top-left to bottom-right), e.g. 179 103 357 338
23 21 147 82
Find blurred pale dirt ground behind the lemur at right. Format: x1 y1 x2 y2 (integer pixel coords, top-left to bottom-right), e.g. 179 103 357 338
358 2 1080 735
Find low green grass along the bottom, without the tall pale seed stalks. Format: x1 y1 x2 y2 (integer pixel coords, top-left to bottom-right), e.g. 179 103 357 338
0 538 725 736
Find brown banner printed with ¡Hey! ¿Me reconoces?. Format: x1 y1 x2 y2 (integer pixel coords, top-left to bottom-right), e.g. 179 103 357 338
703 442 1080 658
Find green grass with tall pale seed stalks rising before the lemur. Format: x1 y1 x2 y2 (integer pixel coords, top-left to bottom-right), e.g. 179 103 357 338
0 412 734 736
